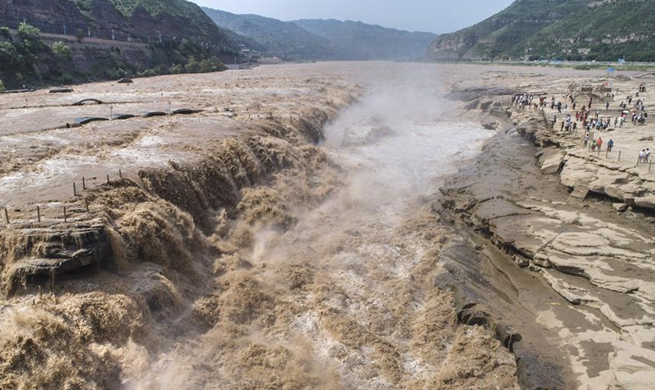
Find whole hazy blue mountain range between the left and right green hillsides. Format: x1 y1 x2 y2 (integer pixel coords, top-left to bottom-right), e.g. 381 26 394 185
203 8 437 60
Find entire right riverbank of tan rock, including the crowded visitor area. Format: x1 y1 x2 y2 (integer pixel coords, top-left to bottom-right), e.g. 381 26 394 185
440 68 655 388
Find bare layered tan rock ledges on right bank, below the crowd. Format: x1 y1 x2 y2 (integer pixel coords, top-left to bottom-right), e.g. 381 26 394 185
441 78 655 388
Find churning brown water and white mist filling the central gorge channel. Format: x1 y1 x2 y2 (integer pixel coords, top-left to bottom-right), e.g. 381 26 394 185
126 74 515 389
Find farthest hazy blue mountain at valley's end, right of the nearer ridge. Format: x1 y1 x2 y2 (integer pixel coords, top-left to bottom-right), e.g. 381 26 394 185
293 19 437 60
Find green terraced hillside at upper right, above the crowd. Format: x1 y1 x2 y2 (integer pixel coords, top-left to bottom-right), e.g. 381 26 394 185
430 0 655 61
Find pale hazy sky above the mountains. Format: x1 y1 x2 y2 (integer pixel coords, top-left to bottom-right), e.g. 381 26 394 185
191 0 514 33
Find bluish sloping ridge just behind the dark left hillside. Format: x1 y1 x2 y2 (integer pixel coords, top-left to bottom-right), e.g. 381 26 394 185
202 7 339 60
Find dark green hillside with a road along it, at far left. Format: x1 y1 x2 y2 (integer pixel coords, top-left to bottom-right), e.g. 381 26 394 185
0 0 256 88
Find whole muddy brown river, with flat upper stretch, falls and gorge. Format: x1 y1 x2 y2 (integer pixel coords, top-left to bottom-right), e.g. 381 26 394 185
0 63 652 390
